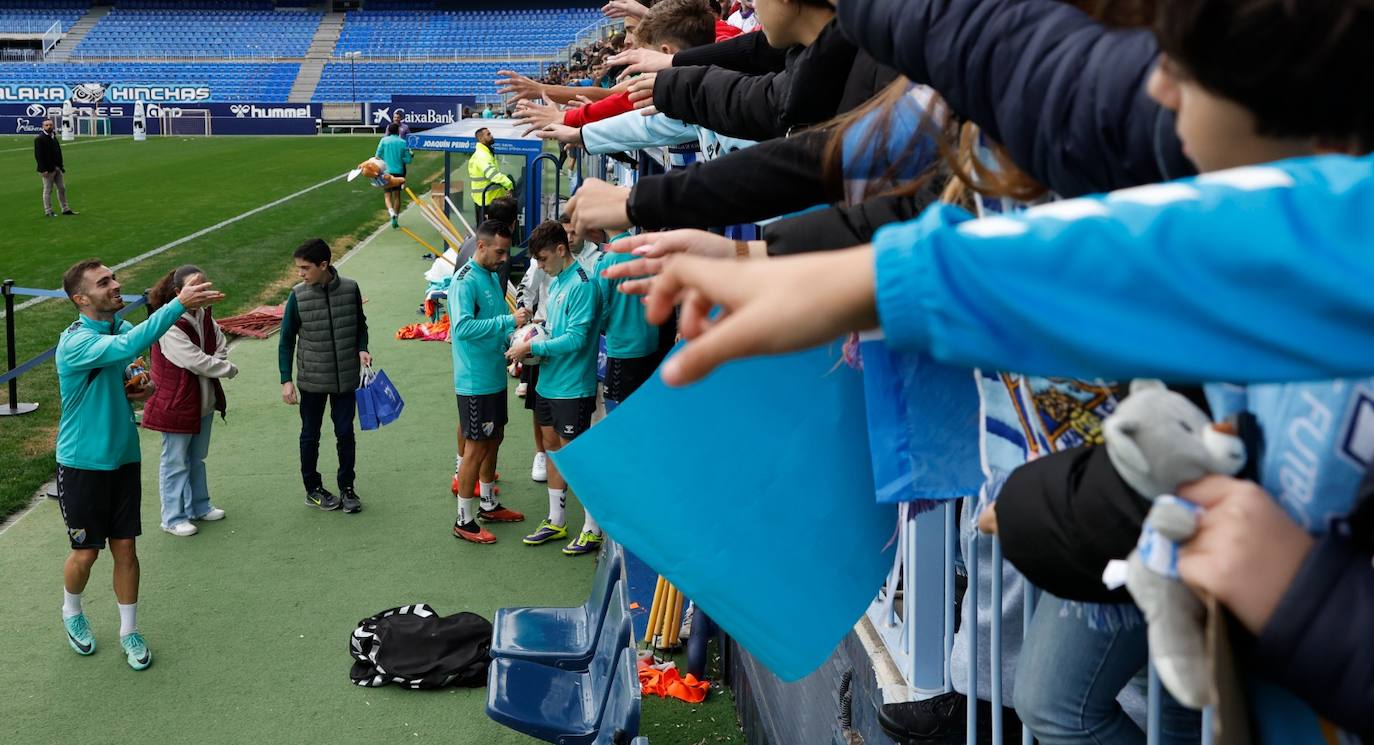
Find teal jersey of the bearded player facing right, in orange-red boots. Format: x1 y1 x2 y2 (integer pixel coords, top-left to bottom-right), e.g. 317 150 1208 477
448 260 515 396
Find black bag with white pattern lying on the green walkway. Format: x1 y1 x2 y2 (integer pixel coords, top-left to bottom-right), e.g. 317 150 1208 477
349 603 492 689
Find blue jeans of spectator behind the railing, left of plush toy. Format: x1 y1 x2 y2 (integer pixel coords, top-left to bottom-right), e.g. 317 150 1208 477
1015 592 1202 745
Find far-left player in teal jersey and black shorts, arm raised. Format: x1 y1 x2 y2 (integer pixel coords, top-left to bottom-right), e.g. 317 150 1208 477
56 258 224 669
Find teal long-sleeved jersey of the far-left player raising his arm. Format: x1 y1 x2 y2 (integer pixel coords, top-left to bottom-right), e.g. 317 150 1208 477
58 298 185 471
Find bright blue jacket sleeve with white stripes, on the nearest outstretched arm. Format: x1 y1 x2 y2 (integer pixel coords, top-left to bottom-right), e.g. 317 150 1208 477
874 155 1374 382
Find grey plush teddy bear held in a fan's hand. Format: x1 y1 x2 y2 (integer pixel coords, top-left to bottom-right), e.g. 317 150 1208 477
1102 379 1246 709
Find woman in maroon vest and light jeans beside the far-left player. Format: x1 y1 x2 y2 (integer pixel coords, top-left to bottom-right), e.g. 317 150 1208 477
143 264 239 536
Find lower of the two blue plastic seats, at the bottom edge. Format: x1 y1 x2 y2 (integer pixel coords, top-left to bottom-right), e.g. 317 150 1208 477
486 591 639 745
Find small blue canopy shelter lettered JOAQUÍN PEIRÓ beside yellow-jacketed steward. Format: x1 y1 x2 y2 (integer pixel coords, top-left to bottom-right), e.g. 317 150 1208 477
407 120 556 243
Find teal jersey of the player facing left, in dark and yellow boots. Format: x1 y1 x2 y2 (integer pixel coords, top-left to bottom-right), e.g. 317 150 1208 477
532 261 599 399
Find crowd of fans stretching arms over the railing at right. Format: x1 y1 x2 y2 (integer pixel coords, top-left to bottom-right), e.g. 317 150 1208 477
486 0 1374 744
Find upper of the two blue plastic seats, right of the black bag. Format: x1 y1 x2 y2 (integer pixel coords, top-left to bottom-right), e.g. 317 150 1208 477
492 540 624 671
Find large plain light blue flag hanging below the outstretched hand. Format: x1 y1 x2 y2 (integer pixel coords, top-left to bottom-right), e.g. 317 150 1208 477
551 342 896 680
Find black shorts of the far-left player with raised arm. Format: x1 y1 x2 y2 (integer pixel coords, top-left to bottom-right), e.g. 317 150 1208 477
58 463 143 548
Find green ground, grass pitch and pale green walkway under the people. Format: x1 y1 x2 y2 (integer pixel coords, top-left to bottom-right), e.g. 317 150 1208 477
0 137 742 745
